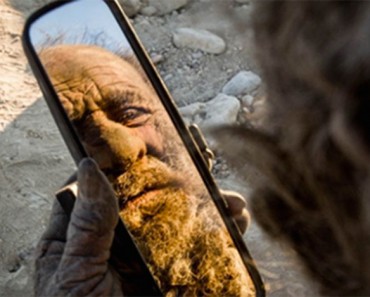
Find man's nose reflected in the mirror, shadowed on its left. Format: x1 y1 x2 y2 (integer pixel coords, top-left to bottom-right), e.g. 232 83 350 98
87 112 147 172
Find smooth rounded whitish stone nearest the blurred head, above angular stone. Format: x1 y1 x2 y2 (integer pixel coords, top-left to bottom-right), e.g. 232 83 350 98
222 71 261 96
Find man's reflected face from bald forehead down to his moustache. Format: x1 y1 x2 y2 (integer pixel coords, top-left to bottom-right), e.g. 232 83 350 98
43 46 191 208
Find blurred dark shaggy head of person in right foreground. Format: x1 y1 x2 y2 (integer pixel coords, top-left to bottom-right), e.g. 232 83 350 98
218 1 370 296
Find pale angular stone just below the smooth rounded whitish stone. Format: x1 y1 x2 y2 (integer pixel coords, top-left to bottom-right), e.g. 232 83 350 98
199 94 240 128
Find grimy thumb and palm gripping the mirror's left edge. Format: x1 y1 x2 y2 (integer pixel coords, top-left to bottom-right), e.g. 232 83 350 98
35 159 123 296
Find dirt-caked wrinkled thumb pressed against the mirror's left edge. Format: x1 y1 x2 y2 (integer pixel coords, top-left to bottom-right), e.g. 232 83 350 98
61 159 118 266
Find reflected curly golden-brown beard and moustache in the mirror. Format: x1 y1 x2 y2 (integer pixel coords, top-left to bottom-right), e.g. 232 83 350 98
114 157 254 296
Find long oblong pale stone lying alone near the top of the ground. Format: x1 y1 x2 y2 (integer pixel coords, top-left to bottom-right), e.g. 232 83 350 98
173 28 226 54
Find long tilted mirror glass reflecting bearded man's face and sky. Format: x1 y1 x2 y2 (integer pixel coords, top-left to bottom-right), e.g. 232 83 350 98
29 0 256 296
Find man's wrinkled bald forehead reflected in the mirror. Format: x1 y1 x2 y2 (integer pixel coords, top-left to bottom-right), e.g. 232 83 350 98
40 45 155 119
